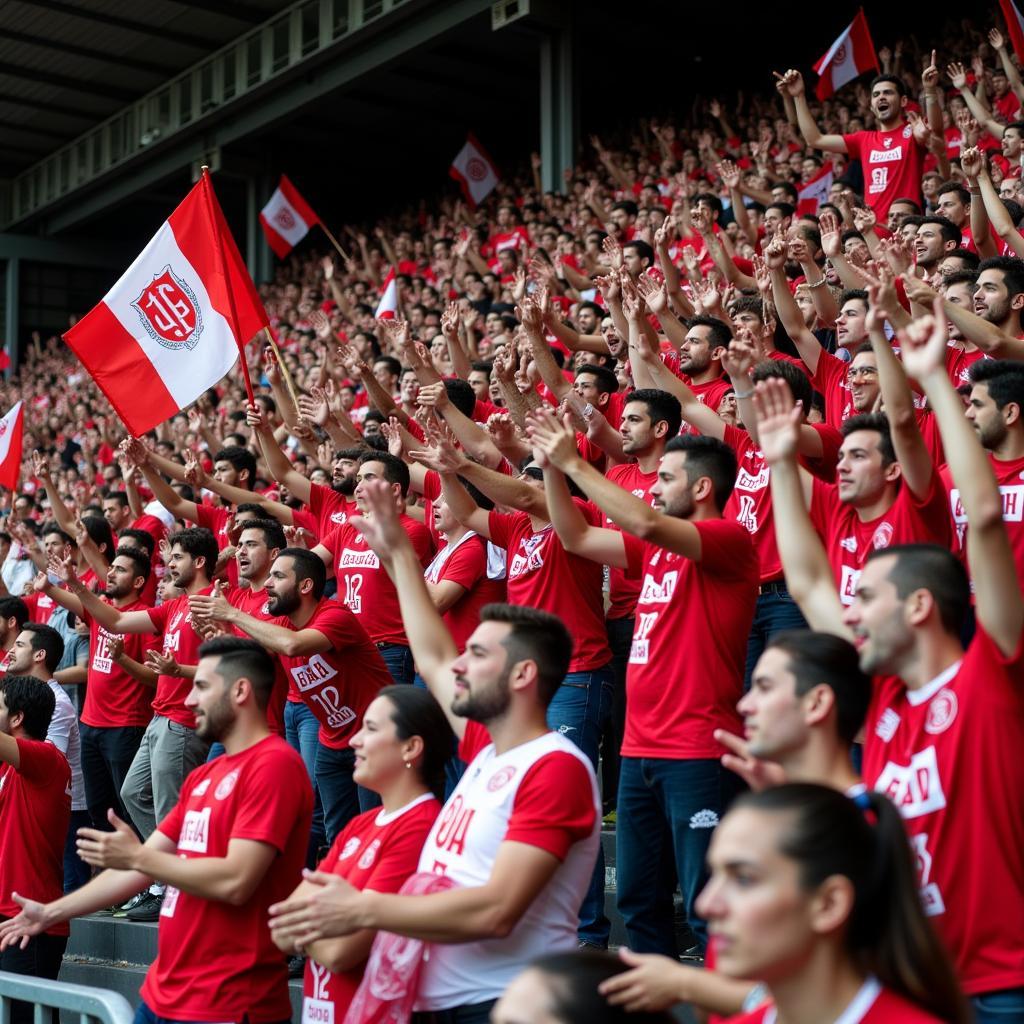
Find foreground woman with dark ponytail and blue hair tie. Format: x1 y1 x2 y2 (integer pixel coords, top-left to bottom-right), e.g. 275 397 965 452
696 783 970 1024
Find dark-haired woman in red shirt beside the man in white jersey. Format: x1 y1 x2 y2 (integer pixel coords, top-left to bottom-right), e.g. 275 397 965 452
271 686 452 1022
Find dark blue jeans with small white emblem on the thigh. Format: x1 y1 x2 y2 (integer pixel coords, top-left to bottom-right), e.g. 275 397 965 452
615 757 740 956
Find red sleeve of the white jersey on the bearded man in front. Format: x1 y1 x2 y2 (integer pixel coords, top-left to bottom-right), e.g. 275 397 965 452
505 751 597 860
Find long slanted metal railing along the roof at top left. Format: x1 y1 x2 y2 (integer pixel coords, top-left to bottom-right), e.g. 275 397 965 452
0 0 409 223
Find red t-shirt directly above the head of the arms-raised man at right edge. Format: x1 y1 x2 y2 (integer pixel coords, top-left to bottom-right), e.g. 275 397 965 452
810 472 952 604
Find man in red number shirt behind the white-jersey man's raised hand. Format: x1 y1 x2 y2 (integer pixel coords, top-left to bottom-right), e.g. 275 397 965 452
313 452 433 683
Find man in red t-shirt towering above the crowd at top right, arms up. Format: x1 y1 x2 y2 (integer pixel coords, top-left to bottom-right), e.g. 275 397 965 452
778 66 943 221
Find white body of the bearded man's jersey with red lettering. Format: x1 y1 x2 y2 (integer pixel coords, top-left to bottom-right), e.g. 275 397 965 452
416 732 601 1011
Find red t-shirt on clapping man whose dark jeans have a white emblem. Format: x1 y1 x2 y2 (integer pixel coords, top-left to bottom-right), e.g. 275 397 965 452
623 519 760 761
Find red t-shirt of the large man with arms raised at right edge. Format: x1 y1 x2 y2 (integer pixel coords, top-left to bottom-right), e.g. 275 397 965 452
863 624 1024 995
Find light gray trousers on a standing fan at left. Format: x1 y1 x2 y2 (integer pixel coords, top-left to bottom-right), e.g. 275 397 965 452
121 715 210 841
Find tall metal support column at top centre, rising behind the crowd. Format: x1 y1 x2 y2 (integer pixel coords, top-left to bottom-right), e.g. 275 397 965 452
541 19 579 191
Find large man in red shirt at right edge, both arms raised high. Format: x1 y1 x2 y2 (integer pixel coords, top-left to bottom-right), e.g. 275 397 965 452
759 311 1024 1010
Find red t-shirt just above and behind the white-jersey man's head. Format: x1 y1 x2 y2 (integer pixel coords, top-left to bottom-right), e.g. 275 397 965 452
487 499 611 672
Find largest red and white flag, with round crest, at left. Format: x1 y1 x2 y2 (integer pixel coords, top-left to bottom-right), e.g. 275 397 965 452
63 173 268 435
